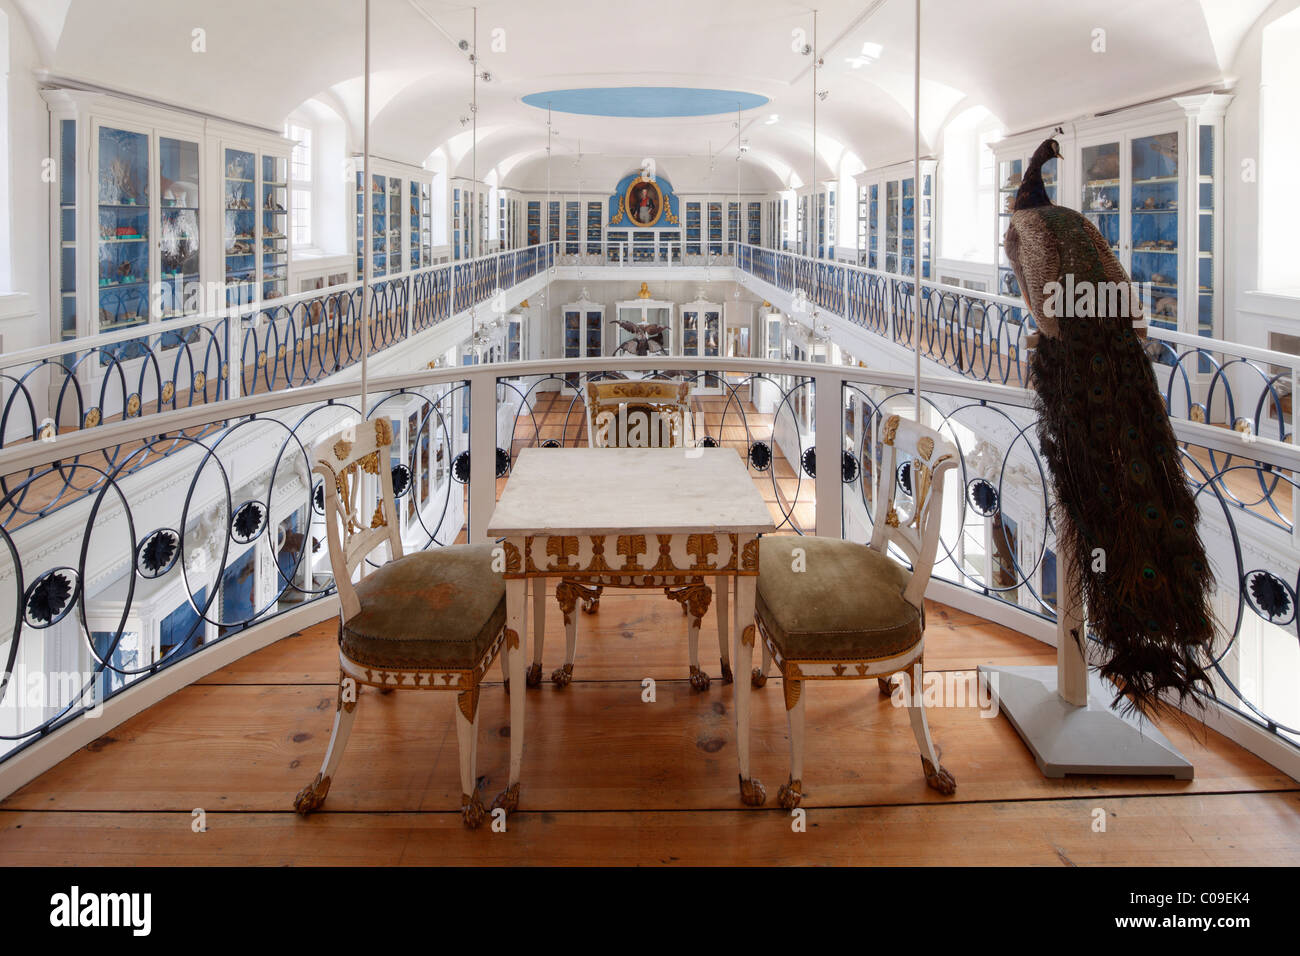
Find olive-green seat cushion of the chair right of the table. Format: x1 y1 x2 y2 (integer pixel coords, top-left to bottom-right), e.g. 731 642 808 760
755 535 922 661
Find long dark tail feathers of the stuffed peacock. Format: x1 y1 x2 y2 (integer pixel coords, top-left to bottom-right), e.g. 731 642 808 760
1031 319 1216 714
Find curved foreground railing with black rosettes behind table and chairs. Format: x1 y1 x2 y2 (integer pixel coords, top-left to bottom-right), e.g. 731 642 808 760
0 356 1300 790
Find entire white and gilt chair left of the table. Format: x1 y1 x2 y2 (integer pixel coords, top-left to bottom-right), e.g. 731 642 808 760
294 419 520 827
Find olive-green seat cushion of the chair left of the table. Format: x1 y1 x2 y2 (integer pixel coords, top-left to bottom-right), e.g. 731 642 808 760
339 544 506 670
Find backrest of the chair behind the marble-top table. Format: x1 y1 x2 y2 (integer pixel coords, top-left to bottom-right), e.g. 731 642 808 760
586 378 690 447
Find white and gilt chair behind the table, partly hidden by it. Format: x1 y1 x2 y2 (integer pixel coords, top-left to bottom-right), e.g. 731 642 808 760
528 379 733 691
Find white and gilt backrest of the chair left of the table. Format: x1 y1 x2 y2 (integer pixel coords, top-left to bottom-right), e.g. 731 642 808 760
312 418 402 620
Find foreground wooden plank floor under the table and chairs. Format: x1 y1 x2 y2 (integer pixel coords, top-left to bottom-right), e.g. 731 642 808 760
0 592 1300 866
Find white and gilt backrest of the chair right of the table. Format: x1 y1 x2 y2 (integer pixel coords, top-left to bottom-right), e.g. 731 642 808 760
871 415 958 607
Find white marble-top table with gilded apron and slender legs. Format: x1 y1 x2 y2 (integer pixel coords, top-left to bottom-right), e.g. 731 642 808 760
488 447 775 805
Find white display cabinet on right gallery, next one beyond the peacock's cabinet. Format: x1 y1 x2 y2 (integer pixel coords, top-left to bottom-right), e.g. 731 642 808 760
857 160 936 278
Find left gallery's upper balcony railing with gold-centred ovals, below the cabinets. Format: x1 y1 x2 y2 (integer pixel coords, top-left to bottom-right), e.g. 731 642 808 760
0 245 554 531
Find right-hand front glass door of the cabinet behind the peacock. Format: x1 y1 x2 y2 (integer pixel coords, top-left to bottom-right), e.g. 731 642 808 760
1128 131 1180 329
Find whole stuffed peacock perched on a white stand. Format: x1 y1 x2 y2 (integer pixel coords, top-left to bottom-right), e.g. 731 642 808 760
1005 139 1214 714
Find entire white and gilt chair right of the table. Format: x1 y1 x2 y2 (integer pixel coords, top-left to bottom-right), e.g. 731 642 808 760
753 415 957 809
